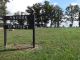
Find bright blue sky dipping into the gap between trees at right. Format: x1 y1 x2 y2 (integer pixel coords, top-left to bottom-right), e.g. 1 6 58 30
49 0 80 10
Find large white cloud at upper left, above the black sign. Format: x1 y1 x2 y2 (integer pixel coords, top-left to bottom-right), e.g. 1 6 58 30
7 0 44 13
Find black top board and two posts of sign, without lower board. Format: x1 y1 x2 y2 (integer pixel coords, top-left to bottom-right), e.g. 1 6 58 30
2 14 35 48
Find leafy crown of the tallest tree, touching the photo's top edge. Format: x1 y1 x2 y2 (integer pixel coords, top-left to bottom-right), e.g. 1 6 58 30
43 1 53 23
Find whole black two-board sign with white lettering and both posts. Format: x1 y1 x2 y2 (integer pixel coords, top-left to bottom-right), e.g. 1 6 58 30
2 14 35 48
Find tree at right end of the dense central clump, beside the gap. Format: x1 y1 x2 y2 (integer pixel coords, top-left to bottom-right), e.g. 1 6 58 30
53 5 63 27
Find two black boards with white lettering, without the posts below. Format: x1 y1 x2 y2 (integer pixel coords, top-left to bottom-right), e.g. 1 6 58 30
2 15 34 29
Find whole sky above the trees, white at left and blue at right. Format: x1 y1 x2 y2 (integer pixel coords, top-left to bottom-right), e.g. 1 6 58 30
7 0 80 14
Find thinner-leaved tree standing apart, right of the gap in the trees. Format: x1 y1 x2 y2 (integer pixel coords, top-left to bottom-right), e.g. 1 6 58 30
66 4 79 27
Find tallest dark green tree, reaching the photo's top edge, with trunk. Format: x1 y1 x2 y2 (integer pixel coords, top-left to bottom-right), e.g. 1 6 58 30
43 1 53 26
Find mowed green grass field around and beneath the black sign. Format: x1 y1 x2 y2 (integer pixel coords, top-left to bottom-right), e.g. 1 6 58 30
0 28 80 60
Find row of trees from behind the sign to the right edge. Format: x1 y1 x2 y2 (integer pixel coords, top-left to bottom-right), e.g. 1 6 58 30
26 1 80 27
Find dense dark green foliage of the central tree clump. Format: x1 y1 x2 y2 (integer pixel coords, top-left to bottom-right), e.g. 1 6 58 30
26 1 62 26
